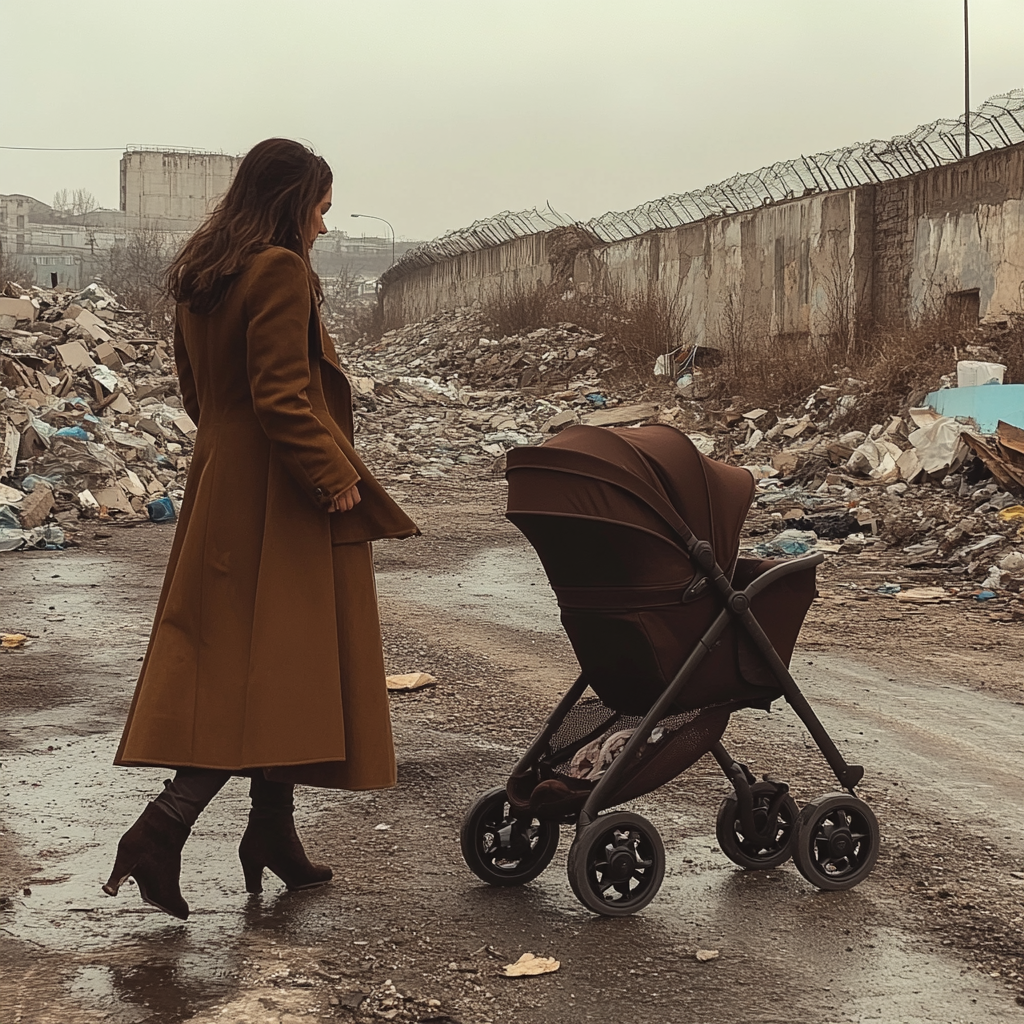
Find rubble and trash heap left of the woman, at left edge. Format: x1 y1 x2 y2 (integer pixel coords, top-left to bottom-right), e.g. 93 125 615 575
0 284 188 551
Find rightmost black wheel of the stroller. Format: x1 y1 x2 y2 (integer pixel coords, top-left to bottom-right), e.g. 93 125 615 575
793 793 879 891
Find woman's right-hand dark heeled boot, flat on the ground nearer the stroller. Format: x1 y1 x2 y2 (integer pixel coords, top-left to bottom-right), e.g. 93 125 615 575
239 772 334 893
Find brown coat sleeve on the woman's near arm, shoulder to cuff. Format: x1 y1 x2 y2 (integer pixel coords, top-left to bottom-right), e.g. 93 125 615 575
246 249 359 508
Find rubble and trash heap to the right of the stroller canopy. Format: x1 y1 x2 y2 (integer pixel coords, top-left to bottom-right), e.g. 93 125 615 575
679 370 1024 600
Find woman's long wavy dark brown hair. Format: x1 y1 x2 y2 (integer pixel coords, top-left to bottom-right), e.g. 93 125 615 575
167 138 334 313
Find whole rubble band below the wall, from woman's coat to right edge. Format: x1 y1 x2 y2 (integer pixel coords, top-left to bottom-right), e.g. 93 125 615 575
339 308 1024 600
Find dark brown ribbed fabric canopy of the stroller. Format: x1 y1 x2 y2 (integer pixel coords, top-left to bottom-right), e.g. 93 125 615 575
507 425 754 592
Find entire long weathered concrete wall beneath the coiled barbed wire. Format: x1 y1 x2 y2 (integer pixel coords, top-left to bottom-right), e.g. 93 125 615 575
384 139 1024 345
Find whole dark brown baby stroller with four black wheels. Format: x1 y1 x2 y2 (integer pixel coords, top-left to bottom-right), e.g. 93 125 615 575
461 426 879 916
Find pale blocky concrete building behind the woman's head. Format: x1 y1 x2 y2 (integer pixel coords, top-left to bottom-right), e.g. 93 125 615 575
121 150 242 229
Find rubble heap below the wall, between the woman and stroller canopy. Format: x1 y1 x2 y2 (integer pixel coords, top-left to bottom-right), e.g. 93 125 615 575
329 307 657 480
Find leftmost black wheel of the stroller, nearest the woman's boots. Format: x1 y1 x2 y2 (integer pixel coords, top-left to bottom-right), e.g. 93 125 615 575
459 786 558 886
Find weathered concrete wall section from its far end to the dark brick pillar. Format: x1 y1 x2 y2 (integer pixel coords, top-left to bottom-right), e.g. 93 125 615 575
384 190 869 344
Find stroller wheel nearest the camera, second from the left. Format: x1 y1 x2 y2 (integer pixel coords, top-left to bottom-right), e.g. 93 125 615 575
567 811 665 918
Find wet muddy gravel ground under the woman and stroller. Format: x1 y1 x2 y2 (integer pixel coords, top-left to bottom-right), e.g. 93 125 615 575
0 473 1024 1024
